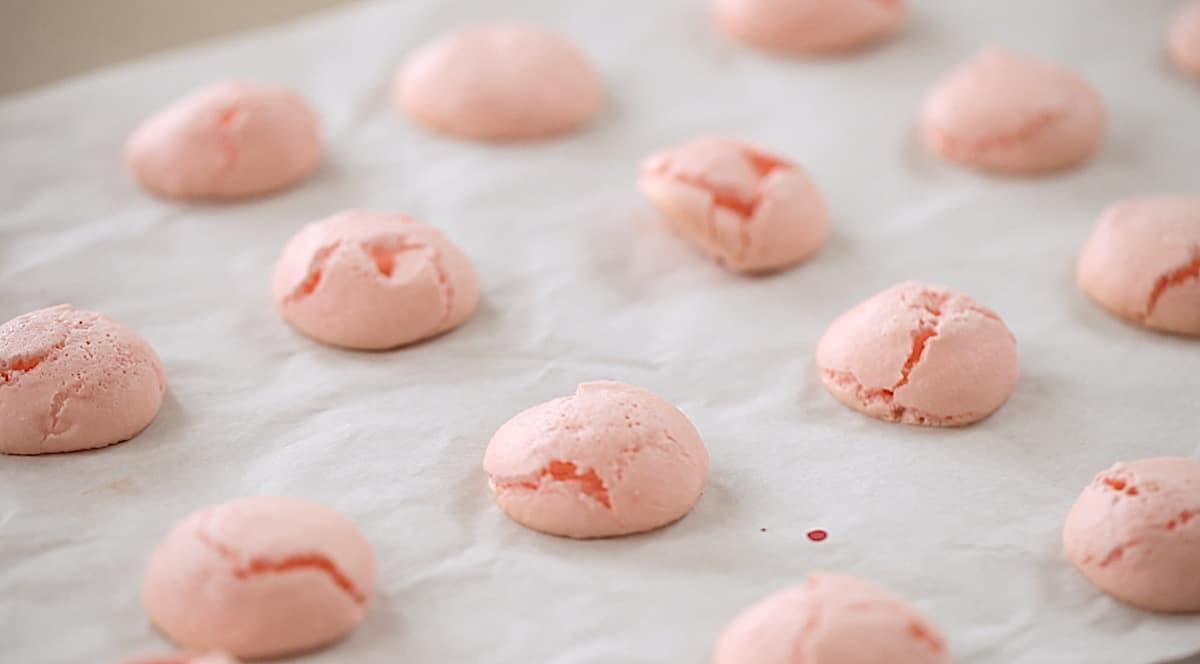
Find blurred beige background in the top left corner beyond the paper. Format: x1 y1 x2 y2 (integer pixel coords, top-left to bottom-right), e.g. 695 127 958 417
0 0 354 95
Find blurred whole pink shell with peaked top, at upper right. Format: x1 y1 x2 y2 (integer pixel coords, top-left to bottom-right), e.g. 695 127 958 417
922 49 1105 174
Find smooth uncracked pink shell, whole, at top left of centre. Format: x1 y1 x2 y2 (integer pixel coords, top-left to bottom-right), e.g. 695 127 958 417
394 24 602 140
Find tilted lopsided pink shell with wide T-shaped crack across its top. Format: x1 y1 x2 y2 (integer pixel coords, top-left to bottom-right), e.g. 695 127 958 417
638 136 829 274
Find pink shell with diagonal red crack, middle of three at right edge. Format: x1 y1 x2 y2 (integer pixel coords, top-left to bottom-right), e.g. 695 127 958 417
1075 196 1200 335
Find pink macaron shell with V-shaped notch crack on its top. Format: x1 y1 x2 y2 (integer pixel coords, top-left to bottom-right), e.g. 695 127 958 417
272 210 479 351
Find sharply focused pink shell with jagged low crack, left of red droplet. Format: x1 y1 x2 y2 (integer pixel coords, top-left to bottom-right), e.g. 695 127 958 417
484 381 708 538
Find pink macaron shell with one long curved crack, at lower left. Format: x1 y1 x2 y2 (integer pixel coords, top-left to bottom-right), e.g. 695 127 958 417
142 496 376 658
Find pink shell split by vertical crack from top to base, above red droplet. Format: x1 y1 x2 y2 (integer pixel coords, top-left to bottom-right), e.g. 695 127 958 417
817 281 1018 426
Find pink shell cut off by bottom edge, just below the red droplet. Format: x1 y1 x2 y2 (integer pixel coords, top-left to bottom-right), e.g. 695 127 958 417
713 573 950 664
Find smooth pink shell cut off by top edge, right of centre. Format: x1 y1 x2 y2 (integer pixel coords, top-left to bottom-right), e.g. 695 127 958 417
713 0 907 53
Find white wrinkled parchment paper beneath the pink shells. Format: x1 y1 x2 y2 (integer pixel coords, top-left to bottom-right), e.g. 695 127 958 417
0 0 1200 664
